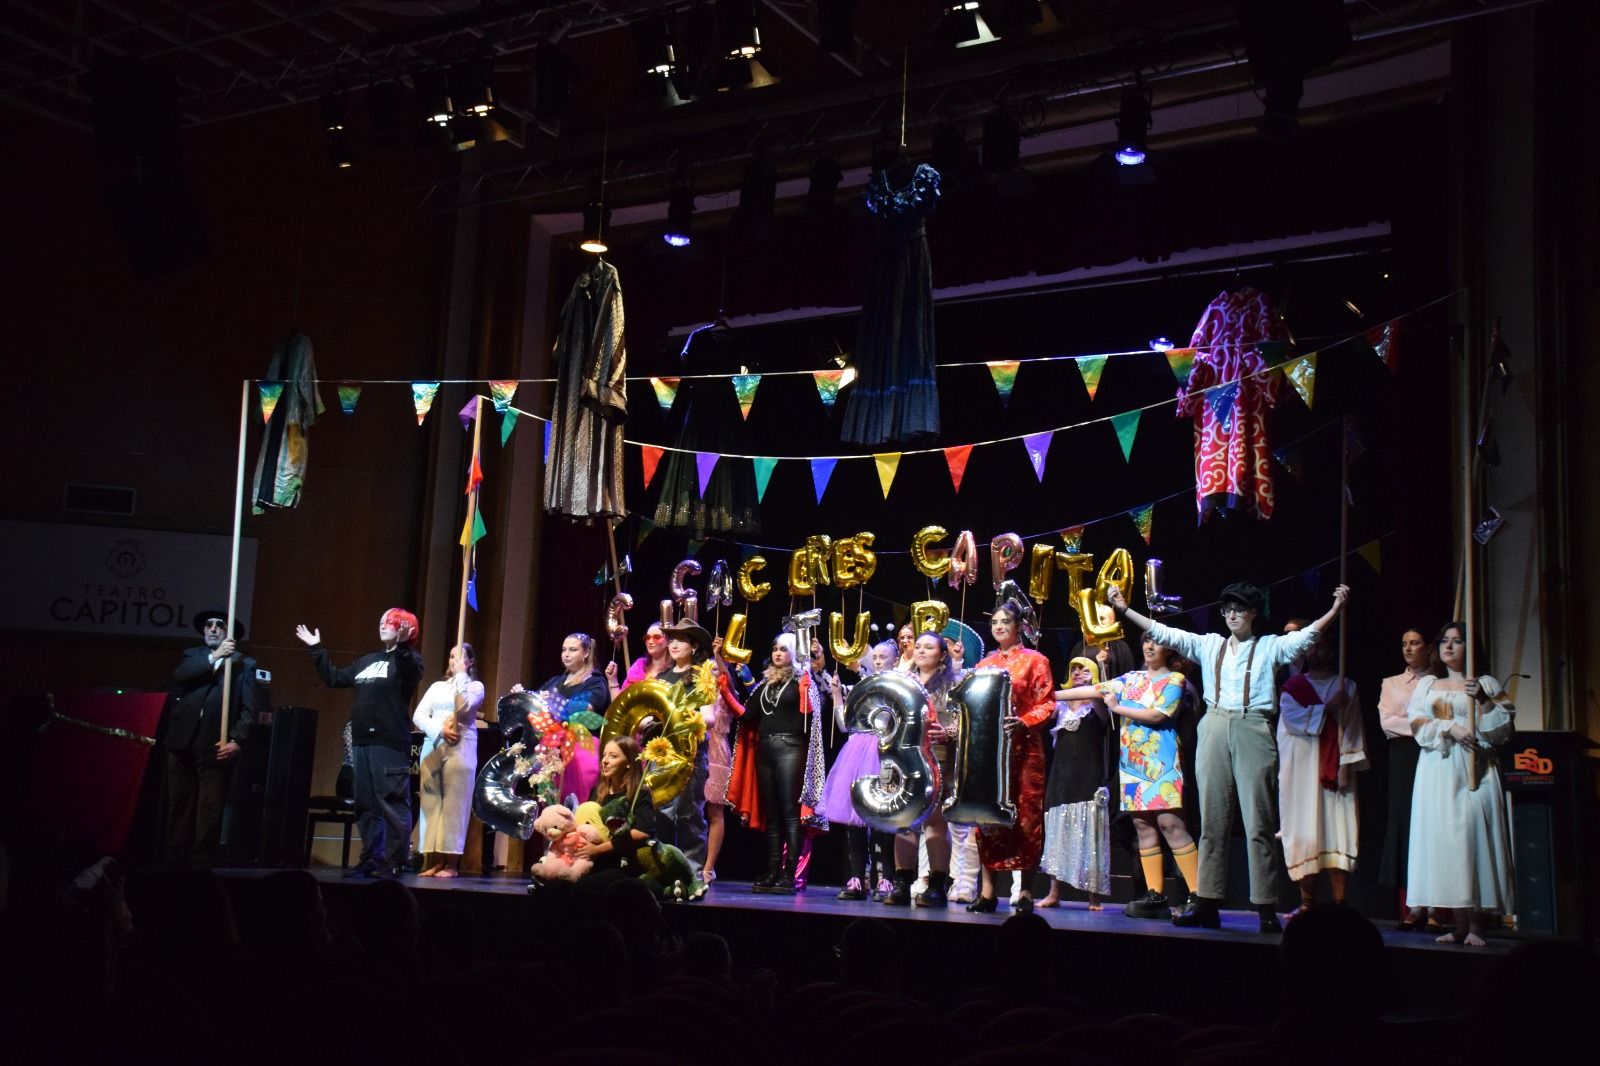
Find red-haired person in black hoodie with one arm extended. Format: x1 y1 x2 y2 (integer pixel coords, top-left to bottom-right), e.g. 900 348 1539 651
294 607 422 877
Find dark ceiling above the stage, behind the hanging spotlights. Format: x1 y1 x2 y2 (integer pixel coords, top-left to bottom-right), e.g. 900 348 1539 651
0 0 1523 210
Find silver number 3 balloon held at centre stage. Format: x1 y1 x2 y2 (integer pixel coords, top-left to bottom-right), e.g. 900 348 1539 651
845 672 939 832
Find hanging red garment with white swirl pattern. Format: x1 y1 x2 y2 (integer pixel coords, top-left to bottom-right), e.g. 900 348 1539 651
1178 288 1288 522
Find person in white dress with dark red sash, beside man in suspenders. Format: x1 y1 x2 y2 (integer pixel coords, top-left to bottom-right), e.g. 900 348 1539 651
1278 640 1368 914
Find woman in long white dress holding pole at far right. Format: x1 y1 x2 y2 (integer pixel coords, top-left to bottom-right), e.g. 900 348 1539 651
1406 623 1517 948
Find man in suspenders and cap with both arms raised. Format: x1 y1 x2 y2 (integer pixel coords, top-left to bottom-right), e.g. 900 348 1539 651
1109 581 1350 933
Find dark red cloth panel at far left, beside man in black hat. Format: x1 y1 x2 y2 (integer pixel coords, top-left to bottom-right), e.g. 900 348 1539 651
27 691 166 855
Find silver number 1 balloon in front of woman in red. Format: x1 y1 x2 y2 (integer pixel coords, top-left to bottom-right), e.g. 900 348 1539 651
944 667 1016 826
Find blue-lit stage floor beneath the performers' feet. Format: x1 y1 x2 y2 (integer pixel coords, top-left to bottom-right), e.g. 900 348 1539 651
233 866 1539 957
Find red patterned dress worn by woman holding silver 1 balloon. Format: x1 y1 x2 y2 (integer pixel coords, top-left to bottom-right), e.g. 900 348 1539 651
978 645 1056 869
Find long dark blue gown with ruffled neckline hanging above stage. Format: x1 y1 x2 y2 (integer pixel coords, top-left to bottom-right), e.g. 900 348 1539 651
840 163 939 445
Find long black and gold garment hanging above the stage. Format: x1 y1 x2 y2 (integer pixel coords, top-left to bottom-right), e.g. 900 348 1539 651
544 259 627 519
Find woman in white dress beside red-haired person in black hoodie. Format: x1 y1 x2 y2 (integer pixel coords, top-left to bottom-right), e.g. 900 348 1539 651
411 643 483 877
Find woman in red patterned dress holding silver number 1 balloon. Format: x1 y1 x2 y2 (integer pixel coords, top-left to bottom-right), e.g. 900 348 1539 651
966 600 1056 912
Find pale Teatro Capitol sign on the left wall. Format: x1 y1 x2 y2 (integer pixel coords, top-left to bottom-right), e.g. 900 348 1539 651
0 520 256 639
